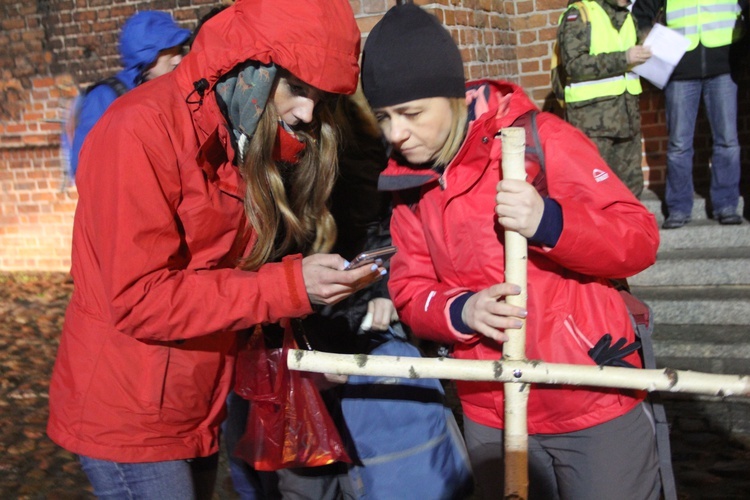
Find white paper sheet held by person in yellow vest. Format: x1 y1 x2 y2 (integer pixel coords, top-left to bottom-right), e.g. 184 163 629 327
633 24 690 89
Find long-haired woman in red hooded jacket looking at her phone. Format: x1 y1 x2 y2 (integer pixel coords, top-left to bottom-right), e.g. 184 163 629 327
47 0 384 498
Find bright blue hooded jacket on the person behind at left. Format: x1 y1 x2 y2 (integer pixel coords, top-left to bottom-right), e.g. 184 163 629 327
70 10 190 179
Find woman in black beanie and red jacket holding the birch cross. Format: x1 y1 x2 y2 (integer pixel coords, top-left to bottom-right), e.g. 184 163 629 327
362 4 659 500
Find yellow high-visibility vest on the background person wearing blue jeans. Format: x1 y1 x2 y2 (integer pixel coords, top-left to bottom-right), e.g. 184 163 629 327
666 0 743 50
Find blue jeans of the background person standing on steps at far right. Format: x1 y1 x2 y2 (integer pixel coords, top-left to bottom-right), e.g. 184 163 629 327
664 74 740 215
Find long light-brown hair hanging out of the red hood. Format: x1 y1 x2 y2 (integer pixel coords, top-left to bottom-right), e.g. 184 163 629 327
240 91 338 270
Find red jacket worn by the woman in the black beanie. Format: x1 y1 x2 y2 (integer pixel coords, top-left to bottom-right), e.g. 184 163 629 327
380 82 659 434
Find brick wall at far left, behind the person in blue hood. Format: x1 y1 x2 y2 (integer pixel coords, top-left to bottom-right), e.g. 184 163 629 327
0 0 221 271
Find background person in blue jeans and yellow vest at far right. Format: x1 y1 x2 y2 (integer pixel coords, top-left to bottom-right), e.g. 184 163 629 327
633 0 748 229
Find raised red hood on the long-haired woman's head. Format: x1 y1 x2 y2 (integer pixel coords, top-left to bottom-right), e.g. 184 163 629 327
175 0 361 94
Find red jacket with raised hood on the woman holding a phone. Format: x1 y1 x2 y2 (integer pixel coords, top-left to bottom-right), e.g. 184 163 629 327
47 0 360 462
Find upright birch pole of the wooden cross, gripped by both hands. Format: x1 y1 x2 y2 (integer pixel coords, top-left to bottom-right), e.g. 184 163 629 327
501 127 529 500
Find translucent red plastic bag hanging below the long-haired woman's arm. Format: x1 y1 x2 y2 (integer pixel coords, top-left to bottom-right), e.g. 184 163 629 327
234 328 351 471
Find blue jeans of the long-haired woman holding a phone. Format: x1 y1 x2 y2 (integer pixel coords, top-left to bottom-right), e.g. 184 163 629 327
78 453 218 500
